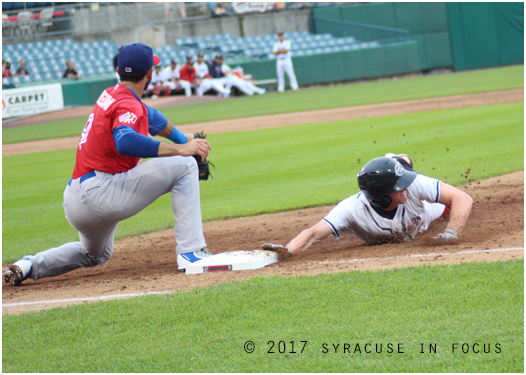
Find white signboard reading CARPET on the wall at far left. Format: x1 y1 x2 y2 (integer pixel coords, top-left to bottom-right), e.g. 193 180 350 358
2 83 64 118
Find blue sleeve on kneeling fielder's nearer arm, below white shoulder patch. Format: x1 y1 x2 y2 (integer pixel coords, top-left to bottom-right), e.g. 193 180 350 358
113 125 161 158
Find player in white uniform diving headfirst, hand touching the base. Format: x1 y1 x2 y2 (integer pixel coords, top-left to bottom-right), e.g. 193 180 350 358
263 154 473 254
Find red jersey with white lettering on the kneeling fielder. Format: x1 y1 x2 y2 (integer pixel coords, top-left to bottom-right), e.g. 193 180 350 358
73 84 148 179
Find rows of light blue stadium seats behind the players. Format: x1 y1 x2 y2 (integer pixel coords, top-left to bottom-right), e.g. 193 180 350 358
2 31 378 85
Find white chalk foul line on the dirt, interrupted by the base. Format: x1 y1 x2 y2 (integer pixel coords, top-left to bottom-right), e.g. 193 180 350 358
2 247 524 307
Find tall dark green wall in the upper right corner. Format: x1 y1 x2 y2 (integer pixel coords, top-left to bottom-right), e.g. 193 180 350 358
312 2 524 70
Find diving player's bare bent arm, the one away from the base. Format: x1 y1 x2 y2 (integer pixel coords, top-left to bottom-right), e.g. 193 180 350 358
439 182 473 238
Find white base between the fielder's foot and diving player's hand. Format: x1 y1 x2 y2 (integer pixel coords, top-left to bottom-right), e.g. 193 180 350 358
185 250 278 275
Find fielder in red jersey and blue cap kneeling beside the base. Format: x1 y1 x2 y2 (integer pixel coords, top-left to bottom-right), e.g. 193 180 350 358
4 43 211 286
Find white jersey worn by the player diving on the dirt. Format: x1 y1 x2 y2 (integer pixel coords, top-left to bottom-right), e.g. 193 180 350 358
323 174 445 245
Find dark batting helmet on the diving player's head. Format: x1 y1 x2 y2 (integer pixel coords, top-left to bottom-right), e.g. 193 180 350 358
358 157 417 209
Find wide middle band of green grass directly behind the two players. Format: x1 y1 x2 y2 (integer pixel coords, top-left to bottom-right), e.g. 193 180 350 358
2 103 524 263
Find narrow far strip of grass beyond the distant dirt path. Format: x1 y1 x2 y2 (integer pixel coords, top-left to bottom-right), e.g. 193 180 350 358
2 65 524 144
